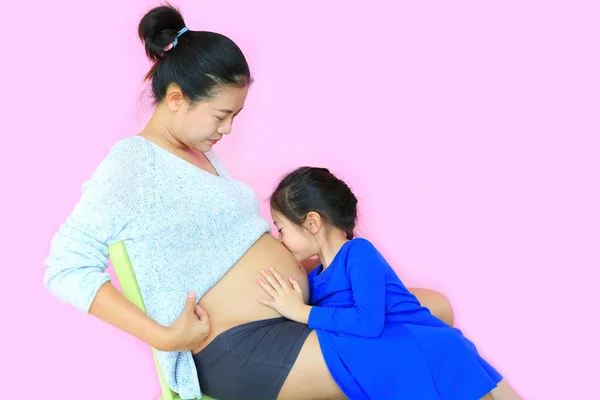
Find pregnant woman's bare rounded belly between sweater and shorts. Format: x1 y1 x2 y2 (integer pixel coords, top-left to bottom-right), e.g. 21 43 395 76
194 234 309 353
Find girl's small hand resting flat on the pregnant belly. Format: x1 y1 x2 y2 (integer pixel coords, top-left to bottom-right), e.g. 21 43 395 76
258 268 311 324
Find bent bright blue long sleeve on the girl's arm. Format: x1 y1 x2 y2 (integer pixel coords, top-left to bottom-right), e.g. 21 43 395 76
308 239 388 338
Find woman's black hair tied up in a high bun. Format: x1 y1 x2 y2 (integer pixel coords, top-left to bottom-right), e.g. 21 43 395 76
138 4 252 103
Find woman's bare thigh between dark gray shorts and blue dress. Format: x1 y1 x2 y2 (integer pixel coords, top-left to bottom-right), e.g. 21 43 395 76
277 331 346 400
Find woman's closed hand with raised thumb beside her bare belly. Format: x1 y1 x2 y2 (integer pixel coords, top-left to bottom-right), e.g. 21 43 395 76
168 292 210 352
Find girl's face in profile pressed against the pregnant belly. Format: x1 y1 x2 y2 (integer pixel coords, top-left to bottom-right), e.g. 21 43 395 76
271 210 318 262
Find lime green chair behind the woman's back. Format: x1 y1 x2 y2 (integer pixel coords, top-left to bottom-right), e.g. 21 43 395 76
108 242 215 400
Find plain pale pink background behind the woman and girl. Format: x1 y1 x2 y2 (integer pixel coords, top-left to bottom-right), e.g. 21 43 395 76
0 0 600 400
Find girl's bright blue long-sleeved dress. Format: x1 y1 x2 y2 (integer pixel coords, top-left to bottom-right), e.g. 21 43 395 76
308 239 502 400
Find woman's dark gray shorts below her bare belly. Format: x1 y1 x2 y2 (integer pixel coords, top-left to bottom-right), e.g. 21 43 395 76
194 318 311 400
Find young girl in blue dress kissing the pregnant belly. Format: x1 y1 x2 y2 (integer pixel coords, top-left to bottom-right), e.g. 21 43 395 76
258 167 510 400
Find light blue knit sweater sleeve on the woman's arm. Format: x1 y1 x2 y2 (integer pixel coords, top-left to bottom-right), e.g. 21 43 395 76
44 138 152 313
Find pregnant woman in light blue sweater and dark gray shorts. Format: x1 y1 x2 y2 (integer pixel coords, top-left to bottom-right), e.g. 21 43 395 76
45 6 452 400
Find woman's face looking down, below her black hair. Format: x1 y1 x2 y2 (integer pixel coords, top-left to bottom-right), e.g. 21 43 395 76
173 86 248 153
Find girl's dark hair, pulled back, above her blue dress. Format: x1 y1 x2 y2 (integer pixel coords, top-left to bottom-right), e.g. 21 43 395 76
271 167 358 239
